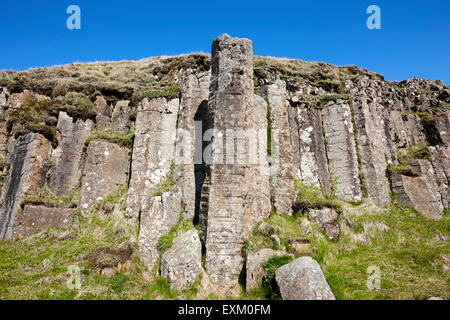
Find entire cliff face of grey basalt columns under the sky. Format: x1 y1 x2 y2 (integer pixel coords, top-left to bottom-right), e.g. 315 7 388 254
0 35 450 299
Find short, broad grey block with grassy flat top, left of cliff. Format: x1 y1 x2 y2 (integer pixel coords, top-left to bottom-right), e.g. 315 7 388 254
81 141 130 209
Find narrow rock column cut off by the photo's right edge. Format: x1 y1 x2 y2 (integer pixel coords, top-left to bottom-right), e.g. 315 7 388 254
428 145 450 208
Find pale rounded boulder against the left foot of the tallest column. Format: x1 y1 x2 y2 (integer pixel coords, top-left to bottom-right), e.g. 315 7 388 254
161 229 203 290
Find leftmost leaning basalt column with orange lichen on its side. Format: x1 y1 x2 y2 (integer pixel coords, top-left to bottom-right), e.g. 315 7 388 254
0 133 52 240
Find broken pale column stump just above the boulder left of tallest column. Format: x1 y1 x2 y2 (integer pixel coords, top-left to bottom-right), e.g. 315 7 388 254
139 192 181 269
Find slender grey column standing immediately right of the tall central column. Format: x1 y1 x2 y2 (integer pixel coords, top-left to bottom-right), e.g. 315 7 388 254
262 80 294 215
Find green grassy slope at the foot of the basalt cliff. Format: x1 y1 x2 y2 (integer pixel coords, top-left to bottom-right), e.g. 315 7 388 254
0 182 450 299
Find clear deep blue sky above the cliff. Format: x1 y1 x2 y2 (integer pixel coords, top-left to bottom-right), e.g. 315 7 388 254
0 0 450 85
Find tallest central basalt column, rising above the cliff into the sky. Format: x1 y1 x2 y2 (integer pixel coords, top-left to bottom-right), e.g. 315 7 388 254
206 35 269 286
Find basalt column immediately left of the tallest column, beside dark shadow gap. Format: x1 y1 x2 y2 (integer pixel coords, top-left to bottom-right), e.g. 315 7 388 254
175 72 211 218
